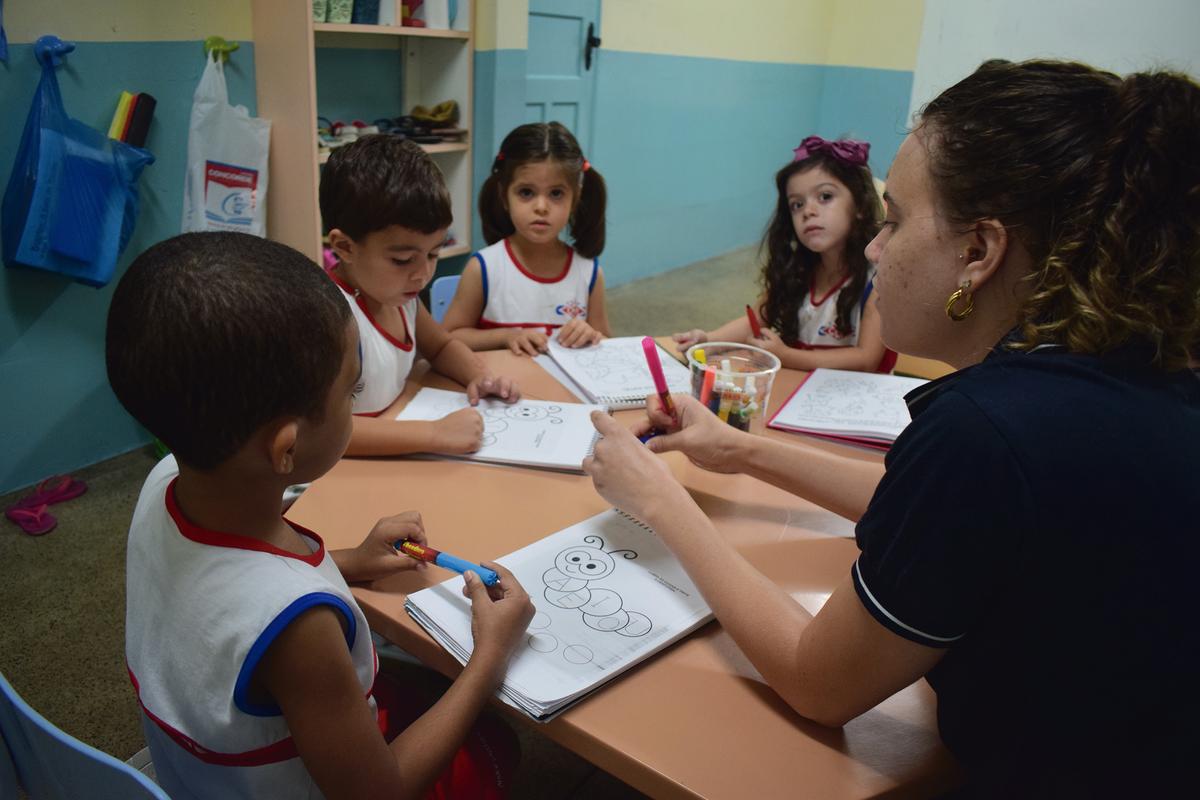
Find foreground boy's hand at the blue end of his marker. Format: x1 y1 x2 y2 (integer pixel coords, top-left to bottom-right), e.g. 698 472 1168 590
462 561 534 682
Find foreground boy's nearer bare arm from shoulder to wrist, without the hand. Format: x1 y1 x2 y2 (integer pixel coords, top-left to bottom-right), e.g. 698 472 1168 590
256 606 503 800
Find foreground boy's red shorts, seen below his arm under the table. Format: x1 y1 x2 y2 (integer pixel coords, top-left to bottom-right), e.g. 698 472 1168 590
372 672 521 800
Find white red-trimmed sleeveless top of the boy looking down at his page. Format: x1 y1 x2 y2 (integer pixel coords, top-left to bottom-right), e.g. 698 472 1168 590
329 272 420 416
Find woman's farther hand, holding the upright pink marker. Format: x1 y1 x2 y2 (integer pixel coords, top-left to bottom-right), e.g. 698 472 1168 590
632 395 749 473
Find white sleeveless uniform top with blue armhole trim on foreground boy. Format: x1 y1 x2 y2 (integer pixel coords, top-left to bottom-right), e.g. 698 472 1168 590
125 456 378 800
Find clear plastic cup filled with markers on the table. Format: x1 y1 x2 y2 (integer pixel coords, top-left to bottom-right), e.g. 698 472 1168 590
686 342 780 433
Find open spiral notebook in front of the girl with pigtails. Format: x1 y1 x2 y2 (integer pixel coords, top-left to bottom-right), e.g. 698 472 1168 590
550 336 691 408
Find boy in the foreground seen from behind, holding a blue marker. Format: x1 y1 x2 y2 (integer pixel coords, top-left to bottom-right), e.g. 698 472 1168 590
106 227 533 800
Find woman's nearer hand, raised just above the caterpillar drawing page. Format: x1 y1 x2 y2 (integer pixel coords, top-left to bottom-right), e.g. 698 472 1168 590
583 411 688 523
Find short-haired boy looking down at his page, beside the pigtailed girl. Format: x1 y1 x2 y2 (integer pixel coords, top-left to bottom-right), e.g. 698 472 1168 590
320 134 520 456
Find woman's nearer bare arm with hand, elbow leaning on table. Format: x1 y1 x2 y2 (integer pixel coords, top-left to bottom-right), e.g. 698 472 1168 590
583 416 944 726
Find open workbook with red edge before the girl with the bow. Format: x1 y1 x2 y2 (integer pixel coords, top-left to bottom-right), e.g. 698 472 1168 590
767 369 926 450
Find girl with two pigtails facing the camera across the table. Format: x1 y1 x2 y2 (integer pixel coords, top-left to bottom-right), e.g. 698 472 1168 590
443 122 611 355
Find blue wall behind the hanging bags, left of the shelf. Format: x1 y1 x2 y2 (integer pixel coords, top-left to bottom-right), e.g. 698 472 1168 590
0 42 254 492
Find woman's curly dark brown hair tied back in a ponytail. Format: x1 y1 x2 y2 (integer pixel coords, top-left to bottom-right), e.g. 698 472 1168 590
919 61 1200 369
